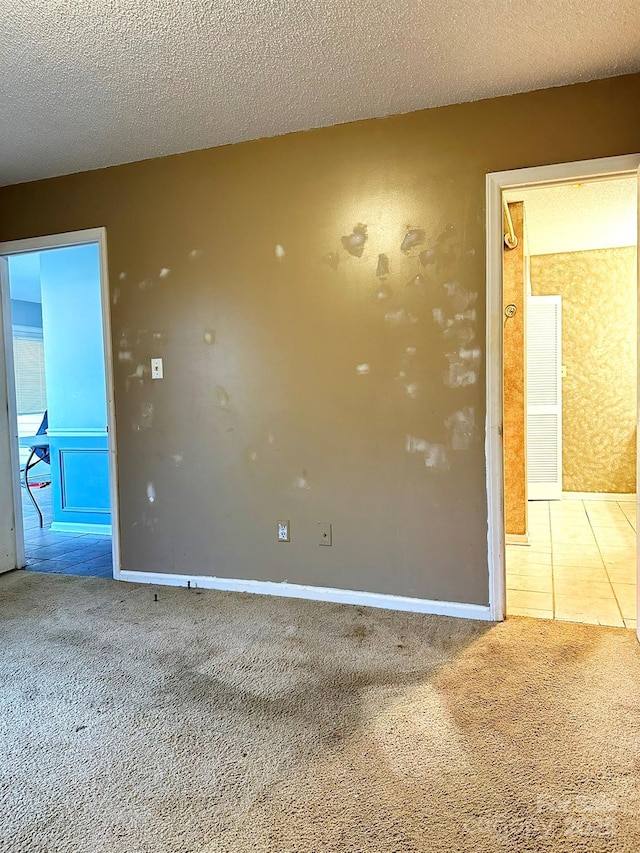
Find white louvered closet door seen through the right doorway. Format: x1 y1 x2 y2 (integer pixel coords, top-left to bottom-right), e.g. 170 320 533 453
526 296 562 501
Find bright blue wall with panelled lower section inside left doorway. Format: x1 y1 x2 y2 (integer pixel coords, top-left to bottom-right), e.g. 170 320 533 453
40 245 111 532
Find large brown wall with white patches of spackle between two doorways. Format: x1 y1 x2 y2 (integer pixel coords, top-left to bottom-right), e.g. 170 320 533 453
0 76 640 604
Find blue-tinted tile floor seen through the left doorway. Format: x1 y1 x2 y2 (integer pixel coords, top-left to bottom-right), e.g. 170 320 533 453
22 486 113 578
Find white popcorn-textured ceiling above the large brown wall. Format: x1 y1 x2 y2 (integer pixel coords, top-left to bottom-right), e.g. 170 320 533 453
0 0 640 184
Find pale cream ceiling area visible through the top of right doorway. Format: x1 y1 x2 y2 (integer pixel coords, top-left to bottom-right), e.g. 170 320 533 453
505 178 638 255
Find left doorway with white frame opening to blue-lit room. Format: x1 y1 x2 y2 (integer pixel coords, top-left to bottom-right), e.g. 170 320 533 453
0 229 119 577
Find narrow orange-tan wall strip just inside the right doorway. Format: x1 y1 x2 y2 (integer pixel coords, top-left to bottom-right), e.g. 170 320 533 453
502 201 527 535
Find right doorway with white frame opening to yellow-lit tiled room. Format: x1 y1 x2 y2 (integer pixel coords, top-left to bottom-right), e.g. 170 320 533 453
487 157 640 630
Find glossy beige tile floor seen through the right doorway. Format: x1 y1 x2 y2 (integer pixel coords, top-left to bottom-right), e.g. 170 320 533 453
506 498 637 628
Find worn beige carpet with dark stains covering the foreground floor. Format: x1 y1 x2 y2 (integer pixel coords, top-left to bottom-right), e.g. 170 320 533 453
0 572 640 853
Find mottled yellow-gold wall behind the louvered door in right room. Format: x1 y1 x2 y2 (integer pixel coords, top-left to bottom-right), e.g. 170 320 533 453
531 246 637 493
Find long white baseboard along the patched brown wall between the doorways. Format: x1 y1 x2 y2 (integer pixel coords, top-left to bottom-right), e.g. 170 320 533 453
114 570 491 621
